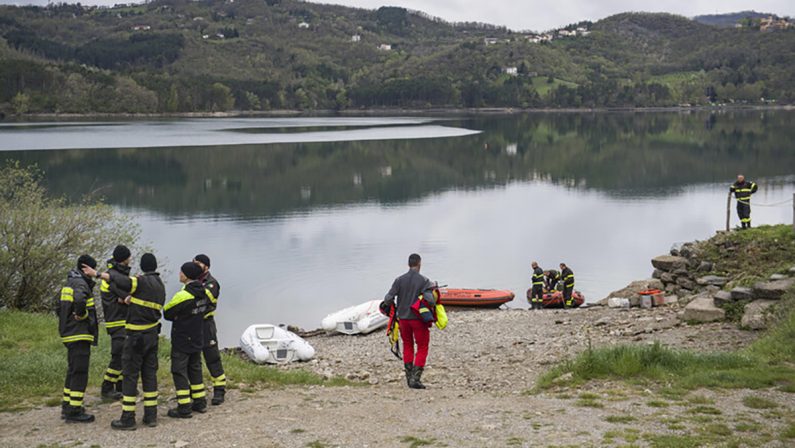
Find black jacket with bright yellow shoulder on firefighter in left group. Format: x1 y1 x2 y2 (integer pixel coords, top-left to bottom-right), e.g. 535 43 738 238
163 280 210 353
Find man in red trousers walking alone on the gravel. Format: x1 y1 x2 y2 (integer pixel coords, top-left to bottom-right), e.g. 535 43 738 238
384 254 433 389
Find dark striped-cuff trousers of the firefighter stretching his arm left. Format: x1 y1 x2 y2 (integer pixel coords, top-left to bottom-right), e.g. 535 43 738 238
122 326 160 412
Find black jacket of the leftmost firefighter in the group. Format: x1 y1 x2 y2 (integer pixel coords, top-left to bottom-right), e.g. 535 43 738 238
58 269 98 345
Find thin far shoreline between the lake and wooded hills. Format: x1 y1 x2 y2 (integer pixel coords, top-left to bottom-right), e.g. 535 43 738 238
6 105 795 123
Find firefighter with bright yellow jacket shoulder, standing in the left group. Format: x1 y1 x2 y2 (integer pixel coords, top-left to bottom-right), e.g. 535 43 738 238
163 261 210 418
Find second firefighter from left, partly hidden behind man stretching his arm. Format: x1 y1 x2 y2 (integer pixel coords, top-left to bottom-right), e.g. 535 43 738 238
99 245 131 400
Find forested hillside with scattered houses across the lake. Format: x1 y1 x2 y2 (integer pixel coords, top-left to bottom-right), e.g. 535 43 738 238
0 0 795 114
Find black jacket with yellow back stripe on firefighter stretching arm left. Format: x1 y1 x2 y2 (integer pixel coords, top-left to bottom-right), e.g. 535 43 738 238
125 272 166 333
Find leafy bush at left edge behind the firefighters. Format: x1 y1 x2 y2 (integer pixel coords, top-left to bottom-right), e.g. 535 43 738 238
0 162 140 311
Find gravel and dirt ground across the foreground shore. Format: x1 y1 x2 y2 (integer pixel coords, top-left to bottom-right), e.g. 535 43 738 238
0 309 795 448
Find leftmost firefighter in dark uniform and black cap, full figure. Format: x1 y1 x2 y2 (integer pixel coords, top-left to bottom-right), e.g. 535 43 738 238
58 255 98 423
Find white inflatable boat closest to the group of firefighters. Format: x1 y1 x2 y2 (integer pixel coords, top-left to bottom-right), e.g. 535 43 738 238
240 324 315 364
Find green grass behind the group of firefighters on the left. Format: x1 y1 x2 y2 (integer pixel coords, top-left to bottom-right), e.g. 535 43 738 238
0 310 350 412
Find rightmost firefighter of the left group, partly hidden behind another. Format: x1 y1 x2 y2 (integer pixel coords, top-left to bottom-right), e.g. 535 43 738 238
193 254 226 406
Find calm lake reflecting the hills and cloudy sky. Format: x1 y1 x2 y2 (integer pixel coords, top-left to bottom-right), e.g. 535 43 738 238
0 111 795 346
